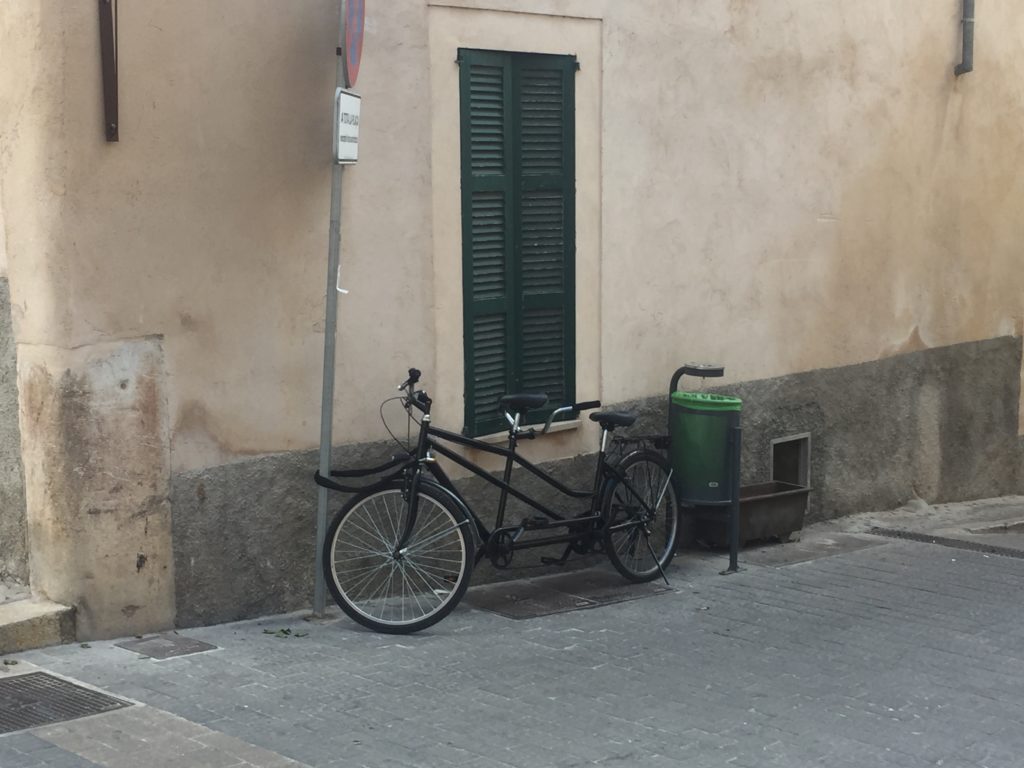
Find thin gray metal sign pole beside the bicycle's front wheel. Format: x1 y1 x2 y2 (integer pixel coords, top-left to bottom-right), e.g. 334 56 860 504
313 7 345 616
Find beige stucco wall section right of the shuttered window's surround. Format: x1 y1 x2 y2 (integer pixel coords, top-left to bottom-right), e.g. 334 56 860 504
602 0 1024 409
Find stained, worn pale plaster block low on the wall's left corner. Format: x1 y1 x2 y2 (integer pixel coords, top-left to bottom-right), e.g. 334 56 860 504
20 342 172 638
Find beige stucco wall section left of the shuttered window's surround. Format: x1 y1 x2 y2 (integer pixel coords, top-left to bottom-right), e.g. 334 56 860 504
0 0 434 470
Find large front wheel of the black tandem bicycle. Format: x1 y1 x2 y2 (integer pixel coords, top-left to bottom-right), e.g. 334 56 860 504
323 482 474 635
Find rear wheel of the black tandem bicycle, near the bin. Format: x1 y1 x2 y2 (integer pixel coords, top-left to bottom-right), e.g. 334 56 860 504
603 450 679 582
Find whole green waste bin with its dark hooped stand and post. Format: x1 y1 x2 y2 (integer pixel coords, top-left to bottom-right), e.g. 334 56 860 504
669 362 742 573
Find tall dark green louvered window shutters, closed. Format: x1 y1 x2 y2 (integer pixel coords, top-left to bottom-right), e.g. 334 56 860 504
459 49 575 435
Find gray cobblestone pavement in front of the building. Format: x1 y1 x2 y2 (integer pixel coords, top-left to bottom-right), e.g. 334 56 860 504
0 507 1024 768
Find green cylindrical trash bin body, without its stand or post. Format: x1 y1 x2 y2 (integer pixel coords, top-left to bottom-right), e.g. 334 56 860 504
669 392 743 504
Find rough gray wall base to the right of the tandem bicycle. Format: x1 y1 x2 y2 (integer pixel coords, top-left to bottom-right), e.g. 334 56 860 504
623 336 1024 521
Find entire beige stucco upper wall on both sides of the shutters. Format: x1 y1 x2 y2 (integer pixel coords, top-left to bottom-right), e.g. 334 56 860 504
0 0 1024 470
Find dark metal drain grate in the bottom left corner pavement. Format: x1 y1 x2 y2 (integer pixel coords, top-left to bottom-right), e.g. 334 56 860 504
0 672 131 733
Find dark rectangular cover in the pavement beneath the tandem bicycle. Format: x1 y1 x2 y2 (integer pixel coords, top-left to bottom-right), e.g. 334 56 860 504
465 570 671 618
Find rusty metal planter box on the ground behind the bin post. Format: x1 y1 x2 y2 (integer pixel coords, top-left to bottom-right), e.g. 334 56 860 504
686 480 811 547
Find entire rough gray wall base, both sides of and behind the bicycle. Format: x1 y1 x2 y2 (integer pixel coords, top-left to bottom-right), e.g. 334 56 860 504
172 337 1024 627
